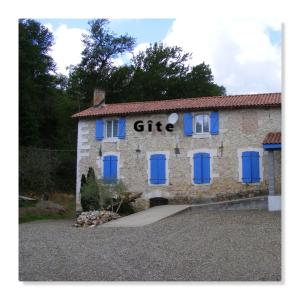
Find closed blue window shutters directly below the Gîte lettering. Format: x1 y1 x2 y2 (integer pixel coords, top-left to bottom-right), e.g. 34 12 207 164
150 154 167 184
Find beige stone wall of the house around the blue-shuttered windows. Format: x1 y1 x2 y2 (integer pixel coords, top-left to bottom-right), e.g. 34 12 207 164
76 108 281 210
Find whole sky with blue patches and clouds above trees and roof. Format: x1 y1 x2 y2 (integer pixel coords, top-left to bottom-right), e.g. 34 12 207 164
37 15 281 94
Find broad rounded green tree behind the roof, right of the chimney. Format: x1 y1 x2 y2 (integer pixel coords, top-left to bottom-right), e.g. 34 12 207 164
107 43 225 102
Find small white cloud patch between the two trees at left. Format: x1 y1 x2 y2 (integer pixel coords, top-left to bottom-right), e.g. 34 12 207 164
45 24 87 75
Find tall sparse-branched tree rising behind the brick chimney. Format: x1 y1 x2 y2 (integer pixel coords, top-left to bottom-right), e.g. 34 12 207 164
69 19 135 109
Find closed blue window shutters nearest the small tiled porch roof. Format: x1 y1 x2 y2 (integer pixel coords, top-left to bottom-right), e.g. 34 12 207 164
242 151 260 183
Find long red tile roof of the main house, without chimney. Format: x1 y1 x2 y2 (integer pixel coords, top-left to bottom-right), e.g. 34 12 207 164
72 93 281 118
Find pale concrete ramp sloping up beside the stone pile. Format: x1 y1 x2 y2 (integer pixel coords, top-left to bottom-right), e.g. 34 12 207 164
100 205 190 227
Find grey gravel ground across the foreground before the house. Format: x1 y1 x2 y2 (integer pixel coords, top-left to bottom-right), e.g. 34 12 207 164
19 210 281 281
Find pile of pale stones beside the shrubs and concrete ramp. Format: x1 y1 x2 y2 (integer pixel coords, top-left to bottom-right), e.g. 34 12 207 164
74 210 120 227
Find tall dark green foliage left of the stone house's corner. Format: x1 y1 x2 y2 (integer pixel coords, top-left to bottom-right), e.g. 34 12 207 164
19 19 77 193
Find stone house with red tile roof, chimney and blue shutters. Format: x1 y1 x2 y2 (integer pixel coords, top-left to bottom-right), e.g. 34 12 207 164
73 90 281 210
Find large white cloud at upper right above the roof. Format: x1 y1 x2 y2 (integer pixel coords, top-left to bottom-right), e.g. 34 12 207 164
163 14 281 94
